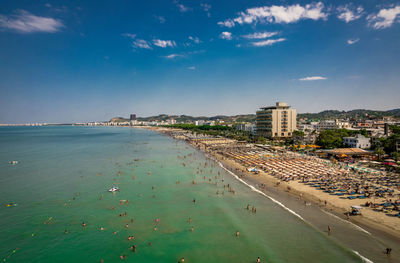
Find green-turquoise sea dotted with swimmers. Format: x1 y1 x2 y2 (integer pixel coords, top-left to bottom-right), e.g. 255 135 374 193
0 127 361 263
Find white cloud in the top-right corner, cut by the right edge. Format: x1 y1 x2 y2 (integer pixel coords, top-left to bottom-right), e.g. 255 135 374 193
367 5 400 29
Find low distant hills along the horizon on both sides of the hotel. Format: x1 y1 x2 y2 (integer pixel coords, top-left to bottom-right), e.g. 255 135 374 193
110 108 400 123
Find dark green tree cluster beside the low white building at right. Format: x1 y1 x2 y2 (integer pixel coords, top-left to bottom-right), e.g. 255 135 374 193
316 129 368 149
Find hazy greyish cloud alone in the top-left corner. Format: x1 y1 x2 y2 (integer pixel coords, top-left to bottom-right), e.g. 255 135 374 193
0 10 64 33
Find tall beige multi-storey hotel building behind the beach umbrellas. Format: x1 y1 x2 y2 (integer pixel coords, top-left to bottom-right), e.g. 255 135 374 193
256 102 297 139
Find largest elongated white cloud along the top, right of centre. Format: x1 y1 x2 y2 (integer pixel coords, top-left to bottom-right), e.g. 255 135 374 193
218 2 328 27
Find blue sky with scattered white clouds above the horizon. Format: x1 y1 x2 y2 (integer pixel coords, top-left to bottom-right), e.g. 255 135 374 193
0 0 400 123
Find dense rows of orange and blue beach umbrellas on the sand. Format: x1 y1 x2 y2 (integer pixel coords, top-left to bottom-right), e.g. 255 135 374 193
221 149 400 221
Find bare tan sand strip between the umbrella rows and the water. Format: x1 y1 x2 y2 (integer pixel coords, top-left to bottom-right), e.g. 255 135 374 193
146 127 400 242
